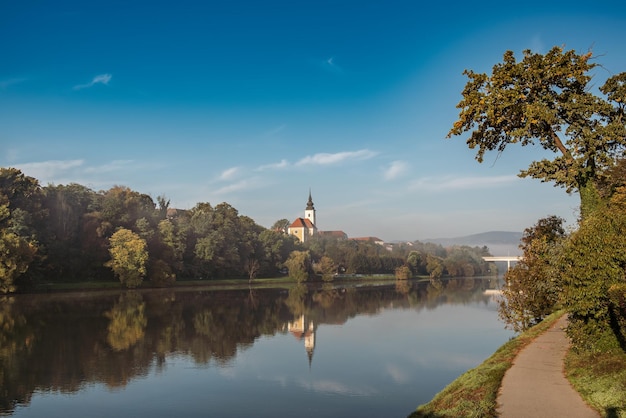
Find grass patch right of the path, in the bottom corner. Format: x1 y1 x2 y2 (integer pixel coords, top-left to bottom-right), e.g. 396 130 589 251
565 340 626 418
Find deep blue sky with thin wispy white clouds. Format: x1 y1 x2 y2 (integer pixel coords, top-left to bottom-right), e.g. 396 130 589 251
0 0 626 240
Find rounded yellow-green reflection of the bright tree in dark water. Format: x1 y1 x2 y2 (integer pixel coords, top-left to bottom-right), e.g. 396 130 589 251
105 292 148 351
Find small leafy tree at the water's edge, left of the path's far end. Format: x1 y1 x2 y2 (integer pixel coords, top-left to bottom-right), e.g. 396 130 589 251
498 216 566 332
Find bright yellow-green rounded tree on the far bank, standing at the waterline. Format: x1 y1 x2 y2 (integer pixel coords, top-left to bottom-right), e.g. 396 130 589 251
106 228 148 289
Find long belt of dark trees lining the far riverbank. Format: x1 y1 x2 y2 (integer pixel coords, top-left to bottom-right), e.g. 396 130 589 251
0 168 494 293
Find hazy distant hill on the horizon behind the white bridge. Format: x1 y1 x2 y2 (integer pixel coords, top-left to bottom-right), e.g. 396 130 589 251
420 231 522 255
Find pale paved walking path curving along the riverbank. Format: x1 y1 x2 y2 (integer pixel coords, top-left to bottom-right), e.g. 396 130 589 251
497 315 600 418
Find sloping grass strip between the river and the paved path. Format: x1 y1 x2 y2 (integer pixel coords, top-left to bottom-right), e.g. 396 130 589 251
409 311 564 418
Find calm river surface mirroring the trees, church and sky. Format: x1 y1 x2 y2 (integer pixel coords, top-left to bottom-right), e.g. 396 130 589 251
0 279 512 418
